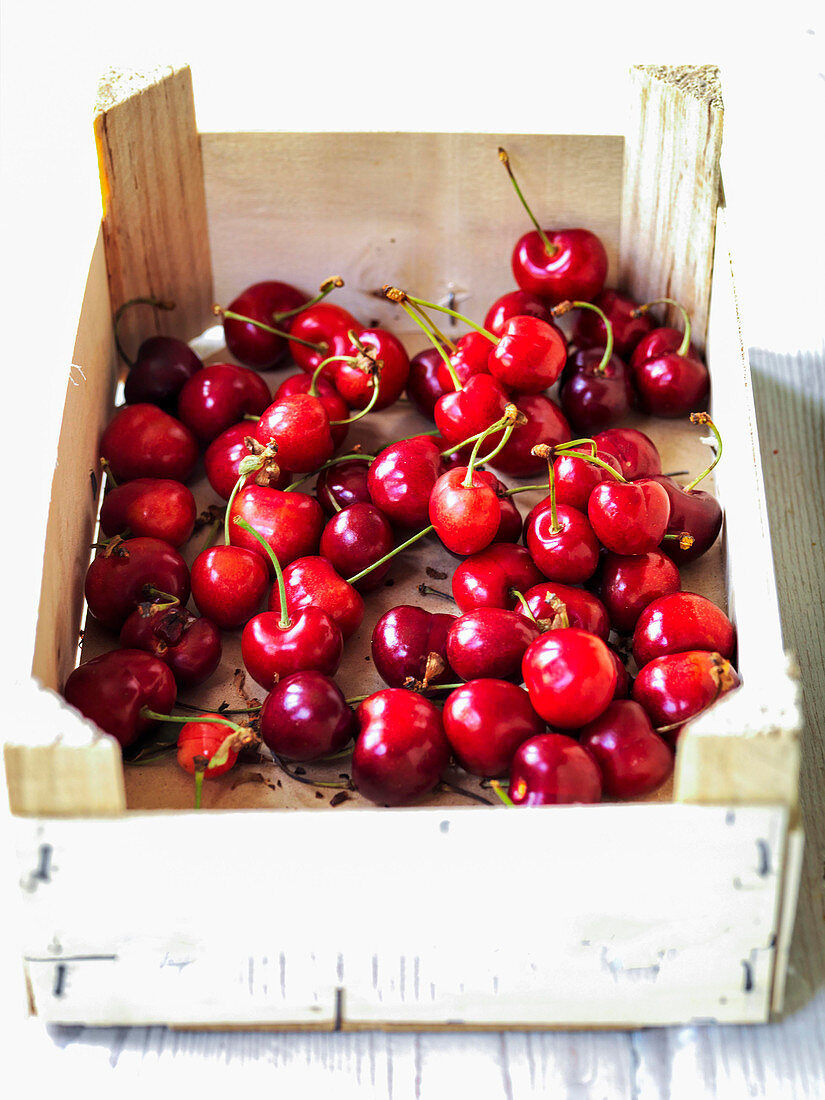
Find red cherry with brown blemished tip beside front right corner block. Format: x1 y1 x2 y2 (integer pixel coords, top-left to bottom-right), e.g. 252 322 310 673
633 649 740 745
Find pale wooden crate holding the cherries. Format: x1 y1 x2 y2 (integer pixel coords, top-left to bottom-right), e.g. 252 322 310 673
6 62 802 1029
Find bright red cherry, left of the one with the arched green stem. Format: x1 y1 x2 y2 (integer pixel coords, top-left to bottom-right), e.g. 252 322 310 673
191 546 270 630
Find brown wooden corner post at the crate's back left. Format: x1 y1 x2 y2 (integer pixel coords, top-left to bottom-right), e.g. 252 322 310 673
95 67 212 353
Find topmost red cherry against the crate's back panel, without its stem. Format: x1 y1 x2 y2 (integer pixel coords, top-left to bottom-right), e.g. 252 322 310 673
512 229 607 306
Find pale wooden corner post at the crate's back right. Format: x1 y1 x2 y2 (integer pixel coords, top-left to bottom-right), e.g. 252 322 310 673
619 65 723 349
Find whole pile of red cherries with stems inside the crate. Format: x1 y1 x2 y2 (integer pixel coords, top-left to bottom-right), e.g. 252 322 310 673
64 151 739 805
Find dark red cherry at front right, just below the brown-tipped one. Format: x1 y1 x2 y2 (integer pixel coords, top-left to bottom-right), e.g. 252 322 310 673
579 700 673 799
